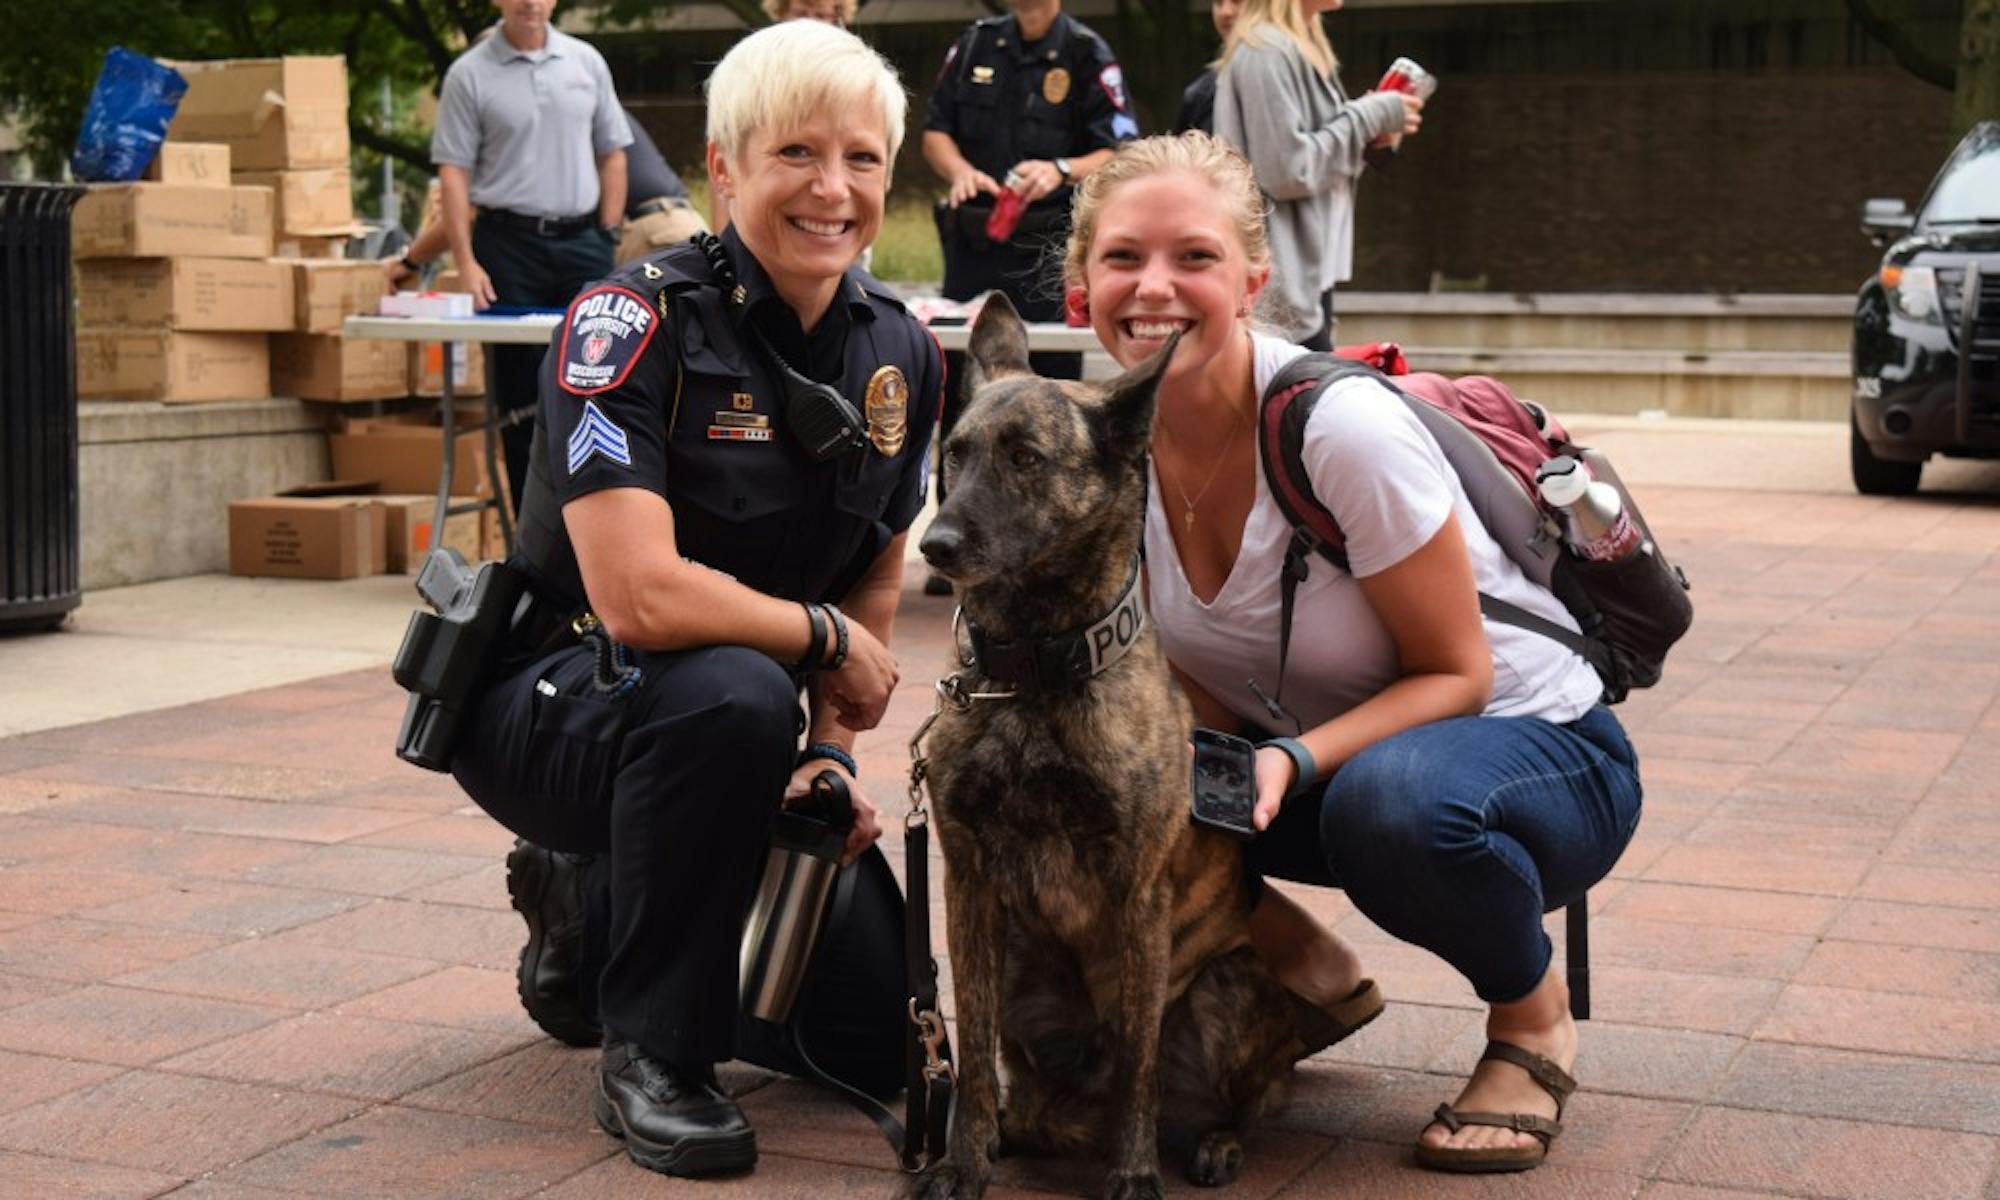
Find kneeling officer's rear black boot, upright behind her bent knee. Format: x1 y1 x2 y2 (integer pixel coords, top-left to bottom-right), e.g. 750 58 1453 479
506 838 602 1046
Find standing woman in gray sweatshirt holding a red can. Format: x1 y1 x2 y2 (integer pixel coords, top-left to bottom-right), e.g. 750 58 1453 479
1216 0 1424 350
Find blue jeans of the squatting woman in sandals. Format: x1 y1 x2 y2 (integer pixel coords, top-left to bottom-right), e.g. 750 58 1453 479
1248 704 1640 1004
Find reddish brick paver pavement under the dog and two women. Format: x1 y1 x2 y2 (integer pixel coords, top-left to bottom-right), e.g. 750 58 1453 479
0 488 2000 1200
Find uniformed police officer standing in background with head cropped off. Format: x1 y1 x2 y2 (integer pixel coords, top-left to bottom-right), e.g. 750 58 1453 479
924 0 1138 380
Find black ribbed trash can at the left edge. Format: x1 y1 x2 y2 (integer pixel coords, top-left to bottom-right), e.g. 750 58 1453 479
0 184 84 632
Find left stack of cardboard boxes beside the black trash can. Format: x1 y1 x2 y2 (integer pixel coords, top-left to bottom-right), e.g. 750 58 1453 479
70 146 294 402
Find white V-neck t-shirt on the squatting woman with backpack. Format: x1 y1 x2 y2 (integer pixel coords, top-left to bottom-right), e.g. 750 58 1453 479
1146 334 1602 732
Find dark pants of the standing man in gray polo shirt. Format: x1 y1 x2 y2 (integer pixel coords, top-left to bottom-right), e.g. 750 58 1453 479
472 220 616 510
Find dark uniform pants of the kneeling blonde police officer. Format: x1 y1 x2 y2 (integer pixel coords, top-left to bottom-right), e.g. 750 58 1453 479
452 646 908 1092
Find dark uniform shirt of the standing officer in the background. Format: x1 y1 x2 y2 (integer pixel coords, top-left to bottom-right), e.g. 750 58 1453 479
924 12 1138 206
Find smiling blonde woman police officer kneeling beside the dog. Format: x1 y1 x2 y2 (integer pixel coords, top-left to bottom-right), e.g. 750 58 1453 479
454 22 942 1174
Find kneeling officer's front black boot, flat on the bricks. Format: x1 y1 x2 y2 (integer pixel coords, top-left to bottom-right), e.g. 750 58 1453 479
590 1038 756 1178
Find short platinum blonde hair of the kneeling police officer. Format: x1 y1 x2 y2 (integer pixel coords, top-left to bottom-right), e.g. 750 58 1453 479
704 20 910 162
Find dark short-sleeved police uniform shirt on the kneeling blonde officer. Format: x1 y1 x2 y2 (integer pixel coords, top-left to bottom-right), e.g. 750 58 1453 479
522 230 944 600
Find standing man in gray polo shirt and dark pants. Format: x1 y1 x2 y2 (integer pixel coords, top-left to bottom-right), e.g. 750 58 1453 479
430 0 632 504
